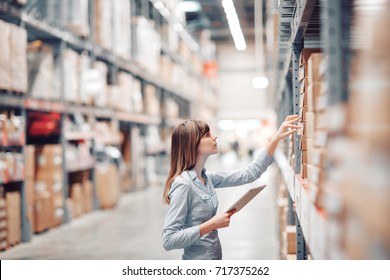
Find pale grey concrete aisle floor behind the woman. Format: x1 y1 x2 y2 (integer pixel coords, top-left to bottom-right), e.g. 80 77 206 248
0 154 279 260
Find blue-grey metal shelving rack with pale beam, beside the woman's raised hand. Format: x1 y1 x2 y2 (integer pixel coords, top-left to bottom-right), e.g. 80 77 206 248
274 0 350 260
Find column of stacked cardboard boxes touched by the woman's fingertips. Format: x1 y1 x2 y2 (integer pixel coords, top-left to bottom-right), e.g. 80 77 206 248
299 49 328 207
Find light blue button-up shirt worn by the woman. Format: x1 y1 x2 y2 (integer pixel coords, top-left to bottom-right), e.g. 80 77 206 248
162 151 273 260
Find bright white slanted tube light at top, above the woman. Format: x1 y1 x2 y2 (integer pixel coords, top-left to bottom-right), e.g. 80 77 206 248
222 0 246 51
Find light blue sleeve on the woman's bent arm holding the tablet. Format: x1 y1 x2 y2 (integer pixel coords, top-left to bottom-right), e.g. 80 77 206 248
162 180 200 251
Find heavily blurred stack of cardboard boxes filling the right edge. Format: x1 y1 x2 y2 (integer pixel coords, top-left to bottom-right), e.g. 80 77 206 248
340 1 390 259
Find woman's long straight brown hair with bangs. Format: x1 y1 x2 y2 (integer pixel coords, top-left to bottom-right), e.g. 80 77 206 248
163 120 210 204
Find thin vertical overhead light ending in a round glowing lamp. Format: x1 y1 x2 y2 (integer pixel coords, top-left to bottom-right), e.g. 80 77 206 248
252 0 269 89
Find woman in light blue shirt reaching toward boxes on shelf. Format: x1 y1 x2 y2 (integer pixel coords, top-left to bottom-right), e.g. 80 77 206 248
162 115 299 260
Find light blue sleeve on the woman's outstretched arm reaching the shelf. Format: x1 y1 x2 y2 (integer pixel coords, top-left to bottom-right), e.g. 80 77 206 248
207 150 274 188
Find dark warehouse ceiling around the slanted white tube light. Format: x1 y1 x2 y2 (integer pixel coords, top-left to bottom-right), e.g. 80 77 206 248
182 0 266 43
